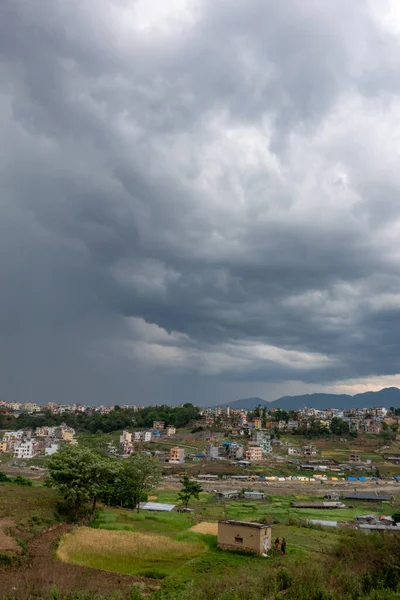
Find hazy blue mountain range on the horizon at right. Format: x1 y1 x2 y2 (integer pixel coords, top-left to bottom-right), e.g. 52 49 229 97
220 387 400 410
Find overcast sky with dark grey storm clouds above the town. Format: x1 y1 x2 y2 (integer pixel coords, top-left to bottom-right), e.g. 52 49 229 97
0 0 400 404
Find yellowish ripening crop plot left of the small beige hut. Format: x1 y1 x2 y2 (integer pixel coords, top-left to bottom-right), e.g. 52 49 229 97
57 527 208 578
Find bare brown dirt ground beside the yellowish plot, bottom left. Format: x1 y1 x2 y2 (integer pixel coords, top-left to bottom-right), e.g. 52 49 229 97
0 524 159 600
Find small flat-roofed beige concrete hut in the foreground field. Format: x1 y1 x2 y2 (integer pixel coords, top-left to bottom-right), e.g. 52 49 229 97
218 521 272 555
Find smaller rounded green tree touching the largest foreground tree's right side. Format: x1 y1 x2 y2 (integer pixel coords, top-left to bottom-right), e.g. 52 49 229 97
119 454 161 512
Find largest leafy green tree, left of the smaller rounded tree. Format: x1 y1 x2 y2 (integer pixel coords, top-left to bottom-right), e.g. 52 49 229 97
47 446 113 517
